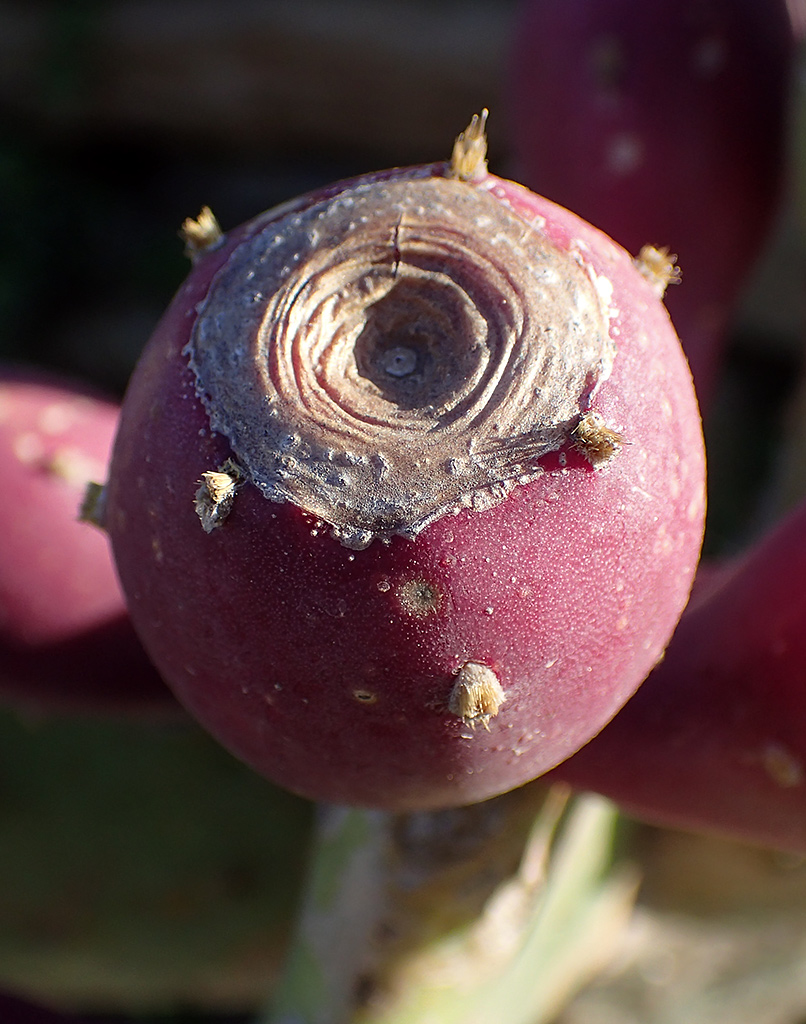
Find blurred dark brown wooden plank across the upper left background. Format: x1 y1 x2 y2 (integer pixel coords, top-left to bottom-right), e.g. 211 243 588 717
0 0 514 162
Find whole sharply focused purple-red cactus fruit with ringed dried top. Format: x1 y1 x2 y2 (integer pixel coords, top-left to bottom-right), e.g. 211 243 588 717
105 120 704 810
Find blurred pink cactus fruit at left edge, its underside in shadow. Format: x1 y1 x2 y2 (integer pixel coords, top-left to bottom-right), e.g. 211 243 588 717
0 368 172 712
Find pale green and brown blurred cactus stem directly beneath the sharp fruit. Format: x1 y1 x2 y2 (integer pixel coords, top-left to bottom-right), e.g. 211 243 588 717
257 783 636 1024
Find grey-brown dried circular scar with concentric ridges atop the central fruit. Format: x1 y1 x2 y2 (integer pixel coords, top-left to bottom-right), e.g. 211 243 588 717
185 114 616 549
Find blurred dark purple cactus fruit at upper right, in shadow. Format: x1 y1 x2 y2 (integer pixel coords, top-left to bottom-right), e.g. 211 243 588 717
507 0 794 411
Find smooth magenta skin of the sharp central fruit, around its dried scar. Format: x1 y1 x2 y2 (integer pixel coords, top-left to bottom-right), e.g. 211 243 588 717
105 165 704 810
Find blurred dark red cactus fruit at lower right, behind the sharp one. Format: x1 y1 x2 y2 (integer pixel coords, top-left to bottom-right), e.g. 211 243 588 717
556 497 806 853
